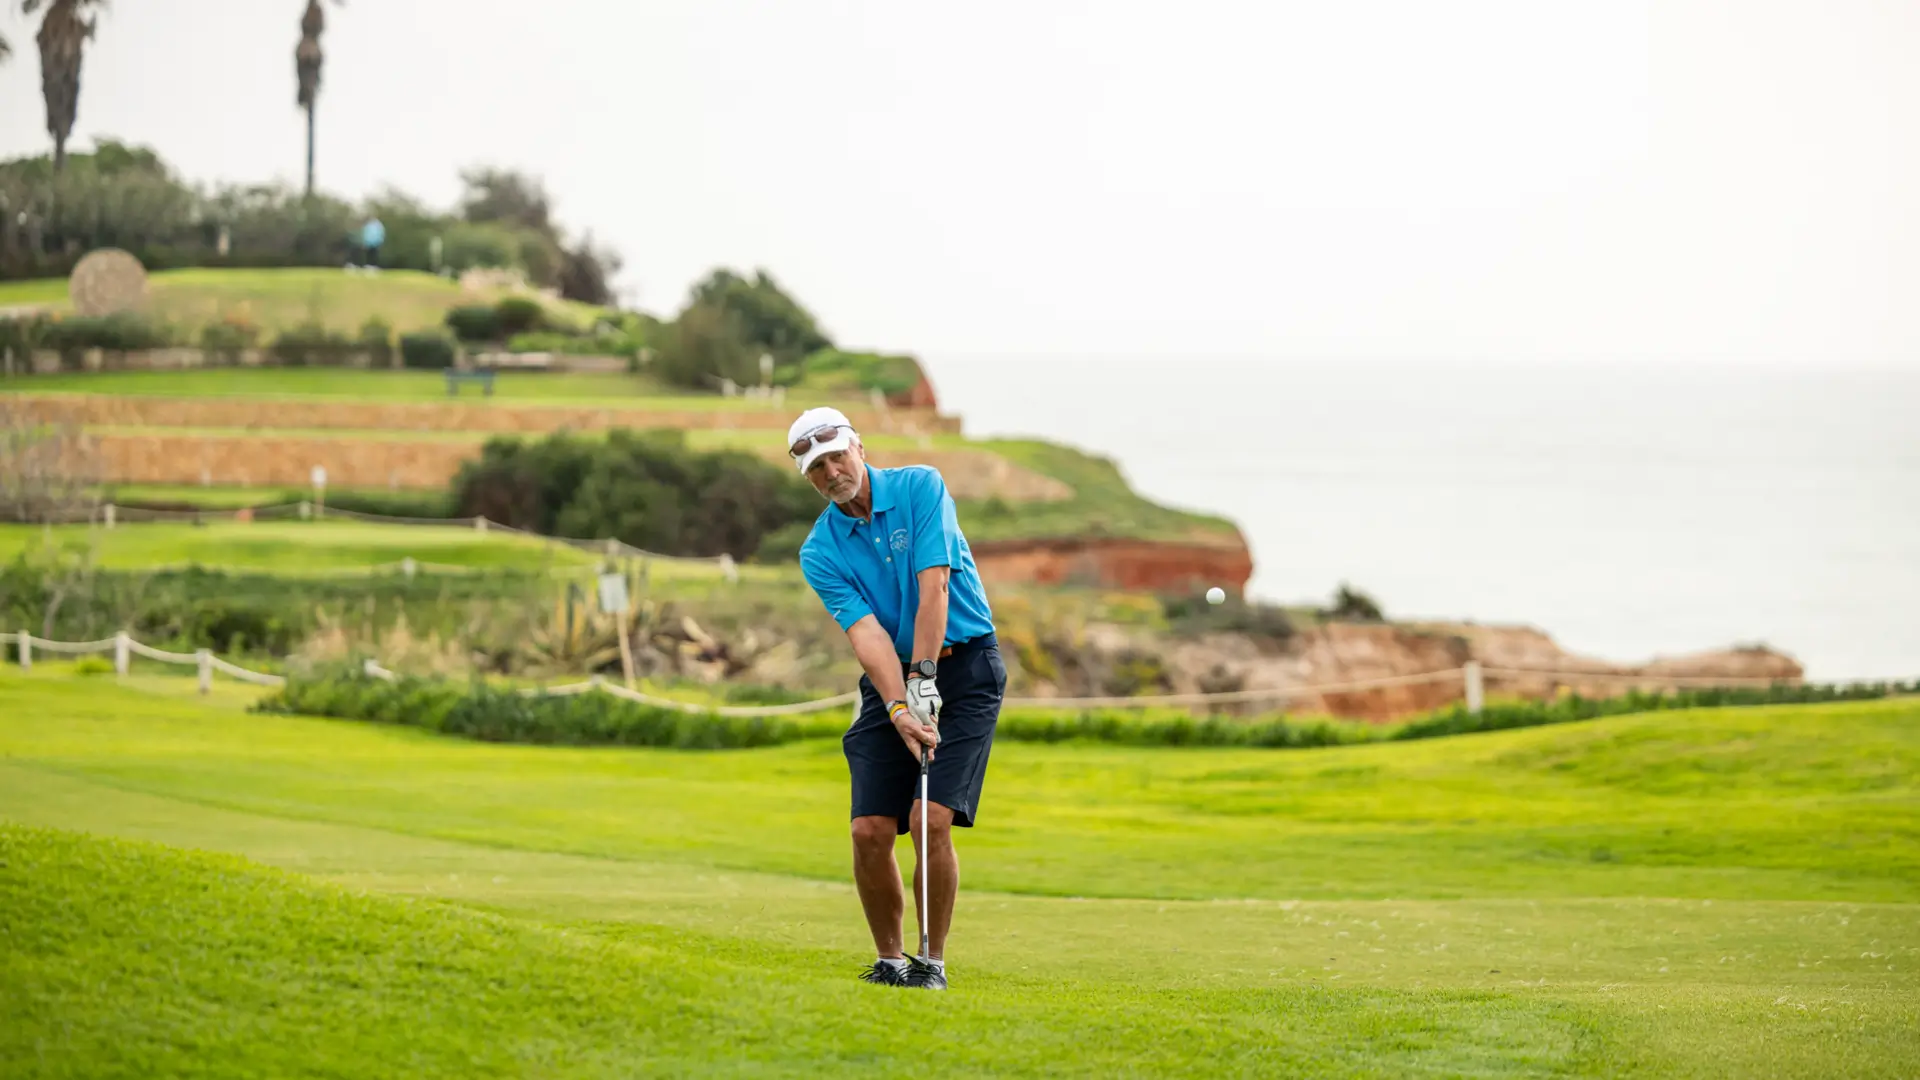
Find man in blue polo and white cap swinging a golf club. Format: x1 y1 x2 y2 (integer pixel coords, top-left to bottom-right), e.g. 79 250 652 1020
787 399 1006 990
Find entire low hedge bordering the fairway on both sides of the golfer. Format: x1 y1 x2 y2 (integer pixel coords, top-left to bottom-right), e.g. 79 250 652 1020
257 675 1920 749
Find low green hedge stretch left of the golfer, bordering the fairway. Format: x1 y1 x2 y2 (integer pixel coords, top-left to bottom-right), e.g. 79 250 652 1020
255 675 847 749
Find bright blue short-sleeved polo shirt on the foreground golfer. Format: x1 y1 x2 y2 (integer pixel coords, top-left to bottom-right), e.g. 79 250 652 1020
801 465 993 661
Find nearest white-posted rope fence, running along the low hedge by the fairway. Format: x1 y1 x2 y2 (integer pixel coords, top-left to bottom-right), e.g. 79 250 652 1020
0 630 1881 719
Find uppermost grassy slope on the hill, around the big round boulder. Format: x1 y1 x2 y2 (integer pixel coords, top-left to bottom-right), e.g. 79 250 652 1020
0 267 599 334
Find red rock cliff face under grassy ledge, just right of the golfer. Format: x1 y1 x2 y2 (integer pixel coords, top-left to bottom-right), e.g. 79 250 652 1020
973 538 1254 594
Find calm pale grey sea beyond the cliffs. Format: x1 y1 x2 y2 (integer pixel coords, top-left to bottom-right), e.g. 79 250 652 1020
927 356 1920 678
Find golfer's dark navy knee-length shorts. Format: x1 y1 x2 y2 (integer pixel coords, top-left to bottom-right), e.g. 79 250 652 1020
841 634 1006 834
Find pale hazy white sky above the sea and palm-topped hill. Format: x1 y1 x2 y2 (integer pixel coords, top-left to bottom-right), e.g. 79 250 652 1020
0 0 1920 365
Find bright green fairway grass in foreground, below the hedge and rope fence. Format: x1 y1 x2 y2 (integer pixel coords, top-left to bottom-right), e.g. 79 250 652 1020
0 669 1920 1076
